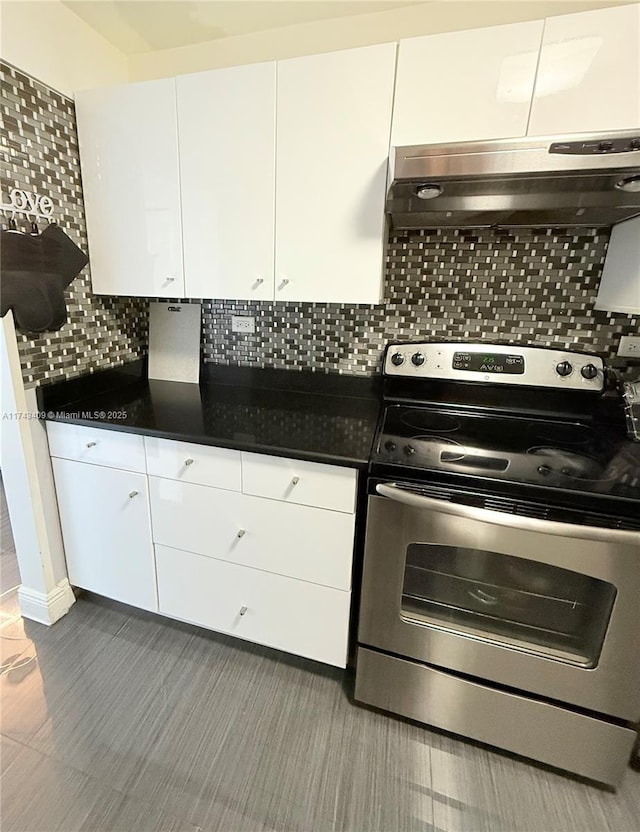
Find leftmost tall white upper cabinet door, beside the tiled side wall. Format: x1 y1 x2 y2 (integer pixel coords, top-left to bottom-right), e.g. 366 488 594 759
76 78 184 297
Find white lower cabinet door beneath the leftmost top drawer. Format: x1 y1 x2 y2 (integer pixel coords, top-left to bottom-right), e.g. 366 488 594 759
52 458 158 612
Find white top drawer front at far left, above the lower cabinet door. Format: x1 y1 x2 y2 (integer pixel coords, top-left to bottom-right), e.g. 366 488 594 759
47 422 146 473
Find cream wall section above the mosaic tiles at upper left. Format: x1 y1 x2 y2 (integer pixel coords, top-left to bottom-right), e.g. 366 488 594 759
0 0 128 96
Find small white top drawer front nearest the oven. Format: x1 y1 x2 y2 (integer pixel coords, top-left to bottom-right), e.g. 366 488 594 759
242 453 357 512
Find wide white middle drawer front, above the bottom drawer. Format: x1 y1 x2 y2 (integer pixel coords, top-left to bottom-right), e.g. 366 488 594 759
149 477 355 590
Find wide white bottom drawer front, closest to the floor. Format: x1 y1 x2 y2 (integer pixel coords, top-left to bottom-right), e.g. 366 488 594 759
156 546 351 667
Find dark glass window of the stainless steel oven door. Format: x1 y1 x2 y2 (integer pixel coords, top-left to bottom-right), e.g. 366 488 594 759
401 543 616 667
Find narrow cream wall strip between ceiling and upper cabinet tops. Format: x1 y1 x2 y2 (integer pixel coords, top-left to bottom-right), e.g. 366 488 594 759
129 0 634 81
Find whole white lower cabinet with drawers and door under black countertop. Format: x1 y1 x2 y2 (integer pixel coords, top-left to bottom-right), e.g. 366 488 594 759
48 423 357 667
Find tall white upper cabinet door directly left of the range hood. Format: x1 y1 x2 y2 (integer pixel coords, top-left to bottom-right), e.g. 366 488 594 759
275 43 396 303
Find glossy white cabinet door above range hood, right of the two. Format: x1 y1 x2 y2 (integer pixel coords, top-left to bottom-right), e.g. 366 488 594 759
529 4 640 136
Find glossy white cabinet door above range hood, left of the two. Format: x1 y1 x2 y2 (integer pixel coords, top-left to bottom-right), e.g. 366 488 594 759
391 20 544 147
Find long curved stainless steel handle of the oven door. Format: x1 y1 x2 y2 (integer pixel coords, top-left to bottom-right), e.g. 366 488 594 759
376 483 640 546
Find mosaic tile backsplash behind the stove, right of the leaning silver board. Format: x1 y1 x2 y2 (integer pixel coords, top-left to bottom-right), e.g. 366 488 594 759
202 224 640 375
